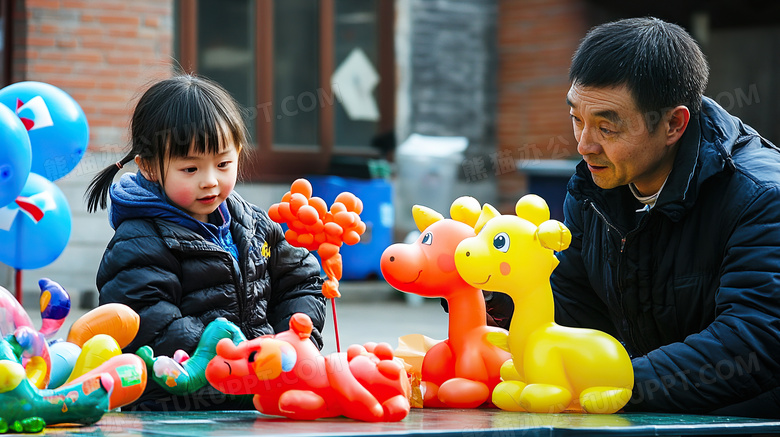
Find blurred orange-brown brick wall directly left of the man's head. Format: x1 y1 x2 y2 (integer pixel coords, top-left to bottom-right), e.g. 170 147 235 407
496 0 587 210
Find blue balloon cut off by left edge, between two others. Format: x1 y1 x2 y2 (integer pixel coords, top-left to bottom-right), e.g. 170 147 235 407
0 105 32 206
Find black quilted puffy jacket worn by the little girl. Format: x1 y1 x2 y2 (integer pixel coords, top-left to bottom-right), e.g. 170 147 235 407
97 192 325 409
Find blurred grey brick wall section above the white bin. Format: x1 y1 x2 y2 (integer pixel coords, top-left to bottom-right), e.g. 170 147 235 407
397 0 497 153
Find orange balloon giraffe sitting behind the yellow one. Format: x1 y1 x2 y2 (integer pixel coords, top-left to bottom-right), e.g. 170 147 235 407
380 197 510 408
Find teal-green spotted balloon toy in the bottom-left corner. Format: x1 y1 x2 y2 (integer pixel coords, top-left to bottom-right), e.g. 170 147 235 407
0 334 114 433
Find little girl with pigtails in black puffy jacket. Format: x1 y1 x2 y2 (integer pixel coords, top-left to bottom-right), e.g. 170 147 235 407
85 75 325 410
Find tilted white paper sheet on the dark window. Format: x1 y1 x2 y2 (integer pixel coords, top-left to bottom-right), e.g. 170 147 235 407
331 48 379 121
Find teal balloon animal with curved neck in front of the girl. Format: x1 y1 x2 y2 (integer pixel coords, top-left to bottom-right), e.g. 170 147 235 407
136 317 246 395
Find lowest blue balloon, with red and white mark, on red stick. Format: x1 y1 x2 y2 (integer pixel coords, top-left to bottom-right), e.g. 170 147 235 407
0 173 71 269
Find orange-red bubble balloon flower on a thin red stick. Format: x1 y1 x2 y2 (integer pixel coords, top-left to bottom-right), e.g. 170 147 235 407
268 179 366 352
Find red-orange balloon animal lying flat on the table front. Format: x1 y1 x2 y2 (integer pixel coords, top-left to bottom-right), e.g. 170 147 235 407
206 313 411 422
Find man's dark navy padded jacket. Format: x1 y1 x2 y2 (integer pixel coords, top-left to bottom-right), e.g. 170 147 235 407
551 97 780 417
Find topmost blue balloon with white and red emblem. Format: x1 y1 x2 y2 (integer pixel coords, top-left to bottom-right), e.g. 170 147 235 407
0 81 89 181
